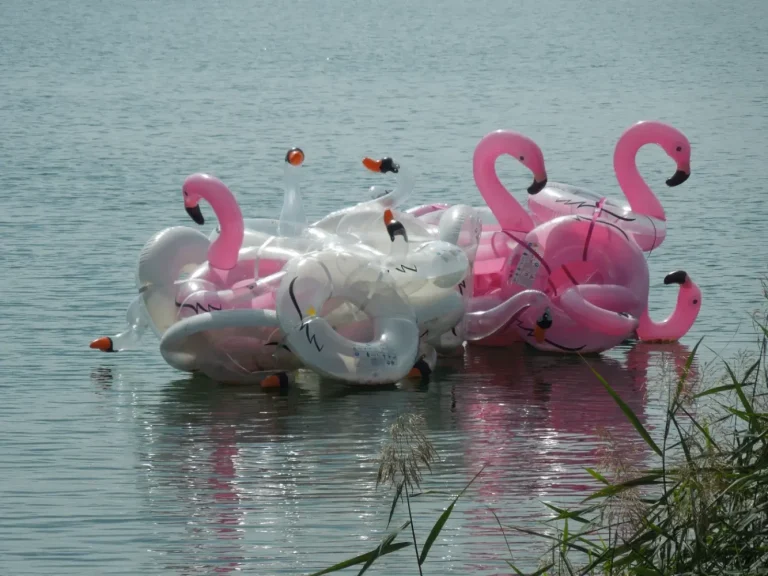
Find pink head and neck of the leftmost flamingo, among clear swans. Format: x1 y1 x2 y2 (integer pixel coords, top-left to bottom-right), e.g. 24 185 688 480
182 173 245 270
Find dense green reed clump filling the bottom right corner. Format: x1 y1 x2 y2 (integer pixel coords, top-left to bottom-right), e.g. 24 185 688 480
502 286 768 576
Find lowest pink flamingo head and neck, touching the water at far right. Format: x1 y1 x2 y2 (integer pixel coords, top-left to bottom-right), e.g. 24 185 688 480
637 270 701 342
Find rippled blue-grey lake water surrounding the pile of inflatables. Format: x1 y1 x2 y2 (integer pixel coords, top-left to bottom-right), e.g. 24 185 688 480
0 0 768 576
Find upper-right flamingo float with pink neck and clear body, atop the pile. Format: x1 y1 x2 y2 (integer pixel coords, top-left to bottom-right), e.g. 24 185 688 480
528 121 691 251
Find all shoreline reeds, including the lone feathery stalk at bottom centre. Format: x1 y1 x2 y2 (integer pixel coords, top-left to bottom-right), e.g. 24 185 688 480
312 282 768 576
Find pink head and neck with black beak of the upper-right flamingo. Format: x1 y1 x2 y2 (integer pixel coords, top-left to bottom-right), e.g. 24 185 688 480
613 121 691 220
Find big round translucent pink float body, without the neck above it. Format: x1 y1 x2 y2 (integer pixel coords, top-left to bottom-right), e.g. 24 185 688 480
479 216 648 353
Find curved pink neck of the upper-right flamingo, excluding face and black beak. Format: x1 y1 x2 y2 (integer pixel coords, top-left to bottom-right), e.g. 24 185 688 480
613 121 687 220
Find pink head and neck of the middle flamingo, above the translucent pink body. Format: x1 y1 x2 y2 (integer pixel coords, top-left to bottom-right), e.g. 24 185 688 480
472 130 546 232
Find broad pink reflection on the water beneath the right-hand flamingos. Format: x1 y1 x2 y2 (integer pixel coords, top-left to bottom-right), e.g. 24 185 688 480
455 343 697 574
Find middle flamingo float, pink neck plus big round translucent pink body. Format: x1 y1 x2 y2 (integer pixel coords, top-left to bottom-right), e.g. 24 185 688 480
460 131 648 352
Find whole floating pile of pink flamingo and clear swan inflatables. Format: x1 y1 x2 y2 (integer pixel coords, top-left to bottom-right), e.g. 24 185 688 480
91 122 701 387
